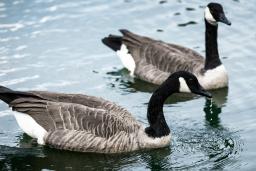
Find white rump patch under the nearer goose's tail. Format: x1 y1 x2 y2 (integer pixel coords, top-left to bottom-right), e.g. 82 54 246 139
14 112 47 145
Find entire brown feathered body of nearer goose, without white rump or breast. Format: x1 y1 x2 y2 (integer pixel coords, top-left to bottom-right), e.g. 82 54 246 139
1 91 143 153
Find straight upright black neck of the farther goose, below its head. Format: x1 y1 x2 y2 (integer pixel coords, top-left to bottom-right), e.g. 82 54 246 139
204 20 221 70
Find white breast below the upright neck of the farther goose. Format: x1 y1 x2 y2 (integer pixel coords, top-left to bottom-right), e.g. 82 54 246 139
197 65 228 90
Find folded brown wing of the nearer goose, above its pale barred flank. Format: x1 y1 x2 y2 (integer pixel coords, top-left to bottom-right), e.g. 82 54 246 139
3 89 140 138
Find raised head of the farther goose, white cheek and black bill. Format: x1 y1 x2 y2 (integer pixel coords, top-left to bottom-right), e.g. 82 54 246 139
204 2 231 26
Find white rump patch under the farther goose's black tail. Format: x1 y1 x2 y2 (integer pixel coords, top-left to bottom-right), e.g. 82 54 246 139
116 44 136 76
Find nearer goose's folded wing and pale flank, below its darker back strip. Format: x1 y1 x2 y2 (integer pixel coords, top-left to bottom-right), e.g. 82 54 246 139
10 98 141 152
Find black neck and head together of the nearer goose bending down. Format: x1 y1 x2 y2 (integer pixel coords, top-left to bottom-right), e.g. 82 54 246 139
145 71 212 137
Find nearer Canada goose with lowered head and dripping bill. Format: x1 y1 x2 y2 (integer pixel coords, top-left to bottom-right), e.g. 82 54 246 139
0 71 211 153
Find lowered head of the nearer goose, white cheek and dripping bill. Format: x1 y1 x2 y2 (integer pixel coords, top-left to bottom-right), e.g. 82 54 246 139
170 71 212 98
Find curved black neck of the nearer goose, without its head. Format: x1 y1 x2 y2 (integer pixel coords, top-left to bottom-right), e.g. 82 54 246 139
145 79 179 137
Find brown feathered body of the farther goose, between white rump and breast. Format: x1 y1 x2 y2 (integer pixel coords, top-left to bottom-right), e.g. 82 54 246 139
121 30 204 84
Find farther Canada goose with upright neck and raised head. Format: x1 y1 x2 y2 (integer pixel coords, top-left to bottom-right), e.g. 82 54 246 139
102 3 231 90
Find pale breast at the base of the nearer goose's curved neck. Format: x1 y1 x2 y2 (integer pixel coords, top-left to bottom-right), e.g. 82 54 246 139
138 128 171 148
